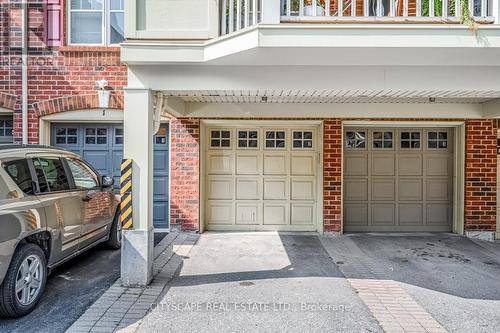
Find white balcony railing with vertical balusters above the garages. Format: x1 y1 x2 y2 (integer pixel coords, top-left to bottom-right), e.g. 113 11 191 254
220 0 500 35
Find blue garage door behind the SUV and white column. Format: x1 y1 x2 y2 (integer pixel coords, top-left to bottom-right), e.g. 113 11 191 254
51 124 169 228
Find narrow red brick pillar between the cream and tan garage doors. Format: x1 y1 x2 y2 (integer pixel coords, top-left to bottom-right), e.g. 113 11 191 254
323 120 342 232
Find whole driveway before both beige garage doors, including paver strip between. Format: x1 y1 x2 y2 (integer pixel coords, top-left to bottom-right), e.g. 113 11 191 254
138 233 500 332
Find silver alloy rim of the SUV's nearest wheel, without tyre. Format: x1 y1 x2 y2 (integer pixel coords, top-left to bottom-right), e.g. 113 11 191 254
16 254 44 306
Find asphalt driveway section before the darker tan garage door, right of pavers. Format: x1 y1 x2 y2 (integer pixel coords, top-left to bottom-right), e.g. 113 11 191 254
349 234 500 332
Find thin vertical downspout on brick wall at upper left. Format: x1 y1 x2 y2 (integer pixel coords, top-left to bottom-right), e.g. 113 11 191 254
21 0 28 144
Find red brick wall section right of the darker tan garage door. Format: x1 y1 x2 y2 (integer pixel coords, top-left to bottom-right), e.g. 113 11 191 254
465 120 497 231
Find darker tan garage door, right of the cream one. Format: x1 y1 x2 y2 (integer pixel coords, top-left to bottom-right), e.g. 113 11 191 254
343 128 453 232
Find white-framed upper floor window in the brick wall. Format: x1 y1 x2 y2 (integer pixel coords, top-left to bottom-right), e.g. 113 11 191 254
69 0 125 45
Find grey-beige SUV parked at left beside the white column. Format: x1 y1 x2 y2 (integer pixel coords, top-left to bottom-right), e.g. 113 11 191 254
0 145 121 317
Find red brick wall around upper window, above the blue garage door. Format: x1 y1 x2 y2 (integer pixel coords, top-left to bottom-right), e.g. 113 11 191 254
0 0 127 143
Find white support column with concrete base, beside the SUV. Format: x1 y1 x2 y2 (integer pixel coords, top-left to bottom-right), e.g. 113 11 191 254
121 88 154 286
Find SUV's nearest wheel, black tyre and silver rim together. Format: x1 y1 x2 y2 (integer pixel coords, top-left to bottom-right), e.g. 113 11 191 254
0 244 47 317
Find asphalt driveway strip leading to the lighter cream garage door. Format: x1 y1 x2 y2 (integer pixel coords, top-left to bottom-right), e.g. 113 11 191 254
139 233 381 332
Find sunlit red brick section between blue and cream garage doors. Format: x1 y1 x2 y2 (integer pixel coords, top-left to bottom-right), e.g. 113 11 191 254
170 119 200 230
